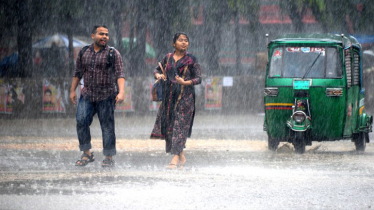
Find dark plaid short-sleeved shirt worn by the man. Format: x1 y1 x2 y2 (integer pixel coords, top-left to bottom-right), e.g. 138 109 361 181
74 44 125 101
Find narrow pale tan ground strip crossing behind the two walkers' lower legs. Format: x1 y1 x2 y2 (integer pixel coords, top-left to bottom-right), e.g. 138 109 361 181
0 137 267 152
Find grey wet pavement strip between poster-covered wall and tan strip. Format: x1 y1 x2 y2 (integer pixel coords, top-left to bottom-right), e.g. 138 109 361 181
0 113 267 139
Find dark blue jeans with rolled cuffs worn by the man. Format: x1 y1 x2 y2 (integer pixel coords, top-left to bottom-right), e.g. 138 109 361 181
76 96 116 156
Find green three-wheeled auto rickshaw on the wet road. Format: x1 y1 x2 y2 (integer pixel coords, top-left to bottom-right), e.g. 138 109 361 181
264 34 373 153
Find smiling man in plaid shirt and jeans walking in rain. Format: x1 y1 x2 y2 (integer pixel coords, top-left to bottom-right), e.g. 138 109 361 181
70 25 125 167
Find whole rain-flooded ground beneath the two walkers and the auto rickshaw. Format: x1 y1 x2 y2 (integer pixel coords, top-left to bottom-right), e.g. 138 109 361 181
0 115 374 209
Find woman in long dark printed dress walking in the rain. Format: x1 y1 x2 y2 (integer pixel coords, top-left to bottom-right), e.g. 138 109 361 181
151 33 201 169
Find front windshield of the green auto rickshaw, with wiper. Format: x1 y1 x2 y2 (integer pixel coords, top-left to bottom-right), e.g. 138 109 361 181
269 46 343 78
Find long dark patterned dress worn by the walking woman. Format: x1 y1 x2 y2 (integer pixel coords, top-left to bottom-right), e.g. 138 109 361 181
151 53 201 155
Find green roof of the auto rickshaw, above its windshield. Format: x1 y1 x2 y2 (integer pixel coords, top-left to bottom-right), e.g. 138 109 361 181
269 34 361 48
